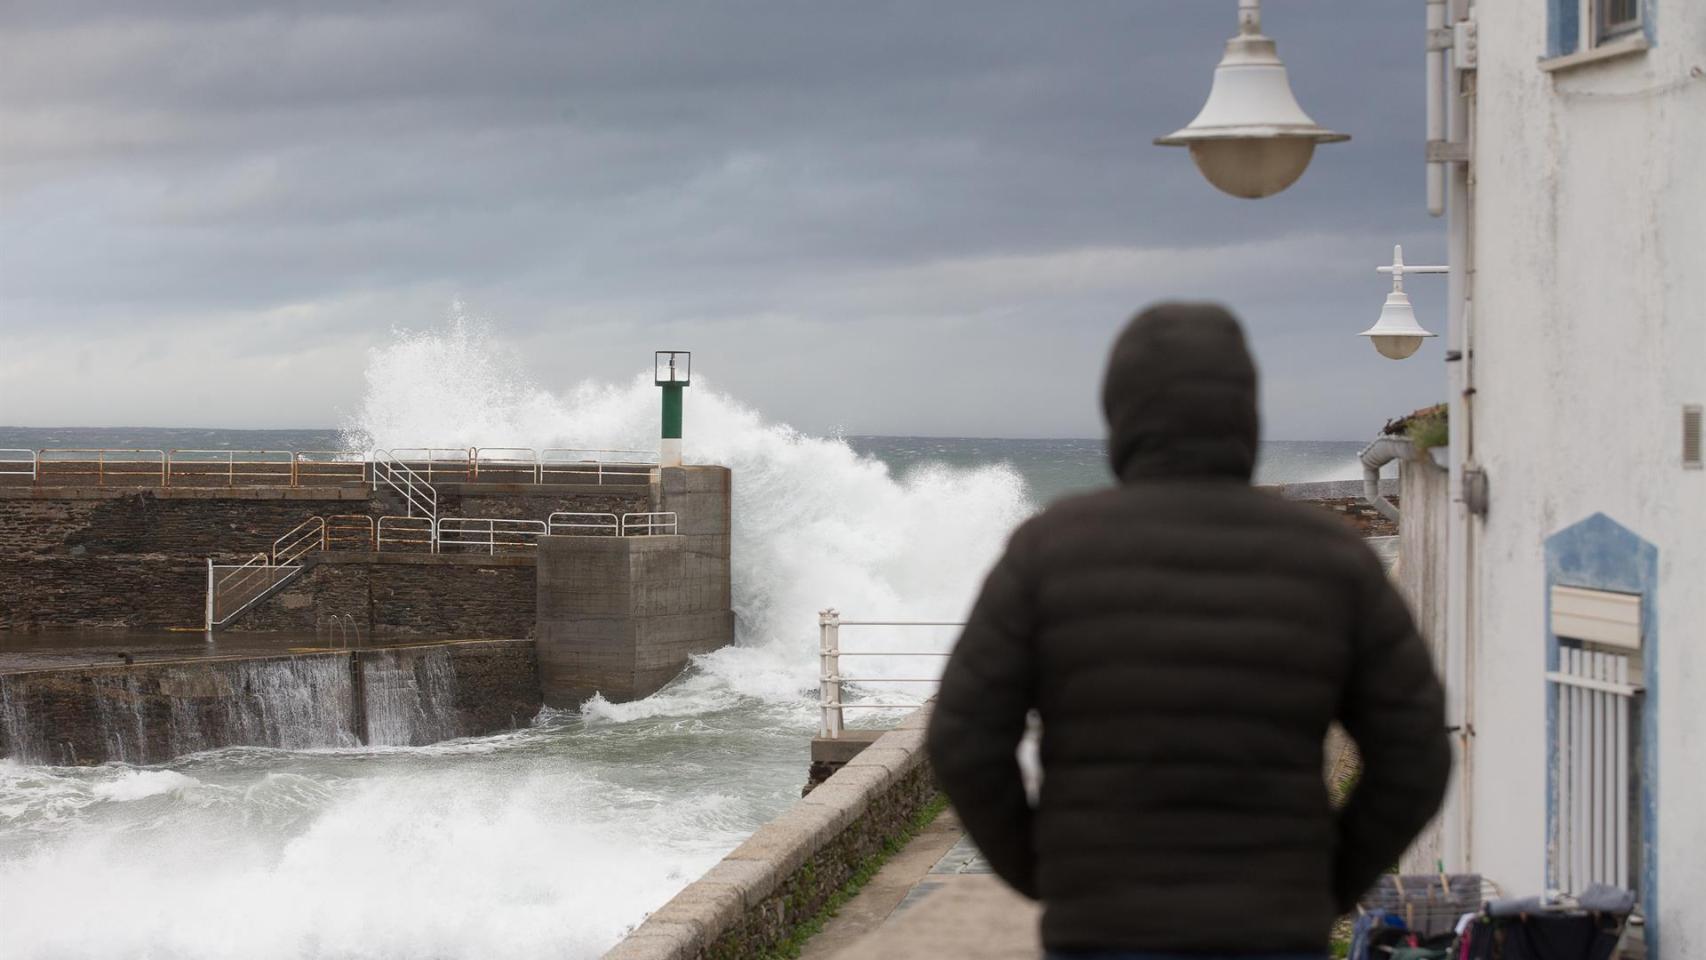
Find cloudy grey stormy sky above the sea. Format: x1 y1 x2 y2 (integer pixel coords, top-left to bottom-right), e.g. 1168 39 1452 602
0 0 1445 440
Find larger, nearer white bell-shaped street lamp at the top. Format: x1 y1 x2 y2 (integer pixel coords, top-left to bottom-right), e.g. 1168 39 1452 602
1155 0 1351 200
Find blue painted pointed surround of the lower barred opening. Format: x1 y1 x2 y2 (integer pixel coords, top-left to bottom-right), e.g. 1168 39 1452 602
1544 513 1662 957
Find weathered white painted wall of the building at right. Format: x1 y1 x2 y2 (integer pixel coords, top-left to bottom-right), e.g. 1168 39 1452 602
1454 0 1706 960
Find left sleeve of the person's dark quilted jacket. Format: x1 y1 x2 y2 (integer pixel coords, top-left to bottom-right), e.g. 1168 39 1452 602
928 527 1037 899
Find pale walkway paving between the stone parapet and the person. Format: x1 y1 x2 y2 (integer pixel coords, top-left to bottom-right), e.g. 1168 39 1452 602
800 810 1042 960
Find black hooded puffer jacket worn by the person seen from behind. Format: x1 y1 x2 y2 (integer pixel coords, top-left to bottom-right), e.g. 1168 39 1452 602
930 304 1450 951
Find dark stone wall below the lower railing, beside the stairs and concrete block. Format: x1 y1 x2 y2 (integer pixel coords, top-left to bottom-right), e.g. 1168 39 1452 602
229 552 537 639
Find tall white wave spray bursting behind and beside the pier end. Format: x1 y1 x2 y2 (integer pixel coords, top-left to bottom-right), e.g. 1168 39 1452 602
346 317 1032 699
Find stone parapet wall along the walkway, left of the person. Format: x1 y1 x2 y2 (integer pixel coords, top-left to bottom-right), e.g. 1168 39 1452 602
604 706 938 960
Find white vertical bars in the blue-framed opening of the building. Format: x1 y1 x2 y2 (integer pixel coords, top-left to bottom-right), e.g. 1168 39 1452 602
1546 646 1643 892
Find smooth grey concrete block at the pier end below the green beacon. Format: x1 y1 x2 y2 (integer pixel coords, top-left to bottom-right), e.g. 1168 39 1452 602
534 467 734 708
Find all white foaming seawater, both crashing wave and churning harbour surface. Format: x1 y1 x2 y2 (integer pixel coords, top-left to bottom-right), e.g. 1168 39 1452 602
0 322 1030 960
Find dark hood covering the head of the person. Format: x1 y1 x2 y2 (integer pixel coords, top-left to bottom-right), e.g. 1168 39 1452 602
1102 304 1261 483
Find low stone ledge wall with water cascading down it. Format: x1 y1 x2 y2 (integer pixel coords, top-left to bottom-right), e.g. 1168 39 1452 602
0 639 541 764
